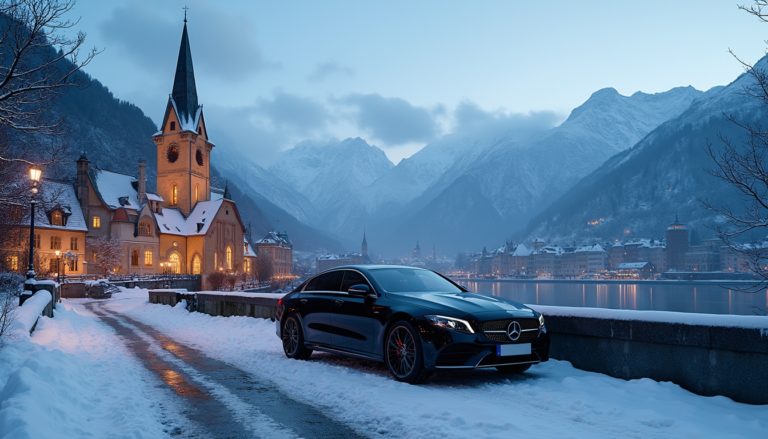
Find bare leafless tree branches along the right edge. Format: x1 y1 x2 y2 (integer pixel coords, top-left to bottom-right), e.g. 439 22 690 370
705 0 768 282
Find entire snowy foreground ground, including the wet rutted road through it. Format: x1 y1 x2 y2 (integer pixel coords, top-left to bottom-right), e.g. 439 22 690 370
0 290 768 439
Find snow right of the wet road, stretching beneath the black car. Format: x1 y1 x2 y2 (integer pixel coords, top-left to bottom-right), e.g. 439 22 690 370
109 289 768 438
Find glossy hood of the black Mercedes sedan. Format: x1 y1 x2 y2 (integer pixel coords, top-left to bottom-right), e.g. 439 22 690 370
390 292 535 317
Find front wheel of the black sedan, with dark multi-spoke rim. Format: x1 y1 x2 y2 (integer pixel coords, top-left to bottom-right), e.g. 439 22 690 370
384 321 427 384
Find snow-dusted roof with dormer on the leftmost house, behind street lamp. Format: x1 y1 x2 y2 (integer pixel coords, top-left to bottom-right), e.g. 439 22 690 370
24 179 88 232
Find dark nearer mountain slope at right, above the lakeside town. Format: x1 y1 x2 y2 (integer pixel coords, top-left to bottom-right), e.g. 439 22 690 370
524 58 768 240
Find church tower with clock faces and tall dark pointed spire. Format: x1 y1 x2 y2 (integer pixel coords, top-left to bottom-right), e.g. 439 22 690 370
153 17 214 216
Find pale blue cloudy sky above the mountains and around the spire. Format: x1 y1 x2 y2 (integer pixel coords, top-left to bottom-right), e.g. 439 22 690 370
73 0 768 166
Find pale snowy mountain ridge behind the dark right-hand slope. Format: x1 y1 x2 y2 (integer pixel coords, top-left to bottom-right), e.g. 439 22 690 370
374 87 701 252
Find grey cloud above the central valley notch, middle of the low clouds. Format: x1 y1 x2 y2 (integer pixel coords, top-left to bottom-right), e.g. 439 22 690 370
338 94 438 147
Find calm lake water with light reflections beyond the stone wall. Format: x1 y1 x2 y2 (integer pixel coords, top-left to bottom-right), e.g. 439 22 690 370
459 280 768 315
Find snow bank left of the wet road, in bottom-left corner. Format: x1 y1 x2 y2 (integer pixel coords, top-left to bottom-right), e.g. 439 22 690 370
0 302 182 439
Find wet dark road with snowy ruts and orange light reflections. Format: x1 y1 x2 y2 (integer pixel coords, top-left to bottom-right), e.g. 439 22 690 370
86 302 362 438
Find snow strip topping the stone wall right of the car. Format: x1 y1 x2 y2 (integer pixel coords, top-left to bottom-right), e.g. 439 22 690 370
526 305 768 330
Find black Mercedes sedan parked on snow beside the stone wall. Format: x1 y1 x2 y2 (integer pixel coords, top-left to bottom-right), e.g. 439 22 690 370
276 265 549 383
